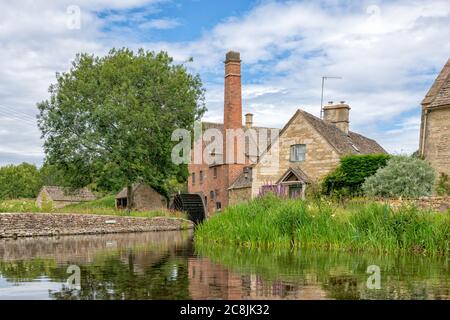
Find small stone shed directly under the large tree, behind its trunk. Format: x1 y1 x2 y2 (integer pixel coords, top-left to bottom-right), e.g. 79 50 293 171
116 183 167 211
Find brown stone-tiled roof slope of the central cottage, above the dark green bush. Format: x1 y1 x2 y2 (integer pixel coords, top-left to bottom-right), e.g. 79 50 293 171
293 110 387 155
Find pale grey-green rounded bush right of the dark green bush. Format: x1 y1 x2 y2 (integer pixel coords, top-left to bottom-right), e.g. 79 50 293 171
362 156 435 198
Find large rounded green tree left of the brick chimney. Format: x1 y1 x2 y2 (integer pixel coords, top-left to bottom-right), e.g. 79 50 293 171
38 49 205 208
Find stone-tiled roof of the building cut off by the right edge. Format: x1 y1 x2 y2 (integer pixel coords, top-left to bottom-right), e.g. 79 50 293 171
422 59 450 107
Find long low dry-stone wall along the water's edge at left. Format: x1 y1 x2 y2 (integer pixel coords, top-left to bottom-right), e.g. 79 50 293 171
0 213 193 238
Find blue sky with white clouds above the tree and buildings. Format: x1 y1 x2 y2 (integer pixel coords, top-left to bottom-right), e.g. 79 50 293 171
0 0 450 165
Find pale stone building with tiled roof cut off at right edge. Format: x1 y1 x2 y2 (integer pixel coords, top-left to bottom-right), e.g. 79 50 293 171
419 59 450 175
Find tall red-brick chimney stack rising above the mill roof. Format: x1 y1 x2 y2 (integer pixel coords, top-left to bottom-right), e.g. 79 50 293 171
223 51 242 130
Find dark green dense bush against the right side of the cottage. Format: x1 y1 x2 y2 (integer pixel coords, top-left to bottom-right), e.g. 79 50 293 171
322 154 390 197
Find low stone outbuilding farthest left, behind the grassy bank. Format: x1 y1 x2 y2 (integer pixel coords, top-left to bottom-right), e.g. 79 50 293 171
36 186 96 209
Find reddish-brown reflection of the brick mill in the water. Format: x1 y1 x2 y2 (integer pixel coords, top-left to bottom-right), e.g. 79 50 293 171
188 258 326 300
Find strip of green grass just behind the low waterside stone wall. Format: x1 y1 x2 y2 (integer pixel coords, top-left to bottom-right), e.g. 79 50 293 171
0 195 186 218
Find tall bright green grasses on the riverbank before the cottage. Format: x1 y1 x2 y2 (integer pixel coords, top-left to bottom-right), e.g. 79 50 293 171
195 195 450 255
